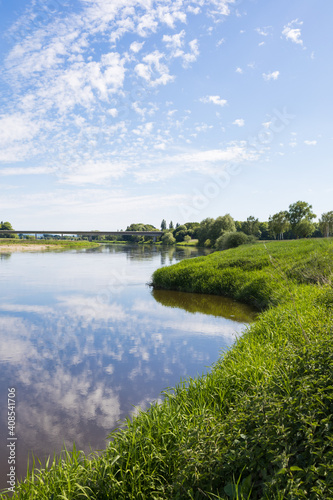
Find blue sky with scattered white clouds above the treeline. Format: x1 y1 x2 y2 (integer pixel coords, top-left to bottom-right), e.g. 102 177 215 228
0 0 333 230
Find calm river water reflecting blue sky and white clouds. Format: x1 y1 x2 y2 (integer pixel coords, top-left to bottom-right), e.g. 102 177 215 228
0 246 254 488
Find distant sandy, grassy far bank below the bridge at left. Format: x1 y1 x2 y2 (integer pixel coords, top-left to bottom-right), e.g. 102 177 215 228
0 238 99 253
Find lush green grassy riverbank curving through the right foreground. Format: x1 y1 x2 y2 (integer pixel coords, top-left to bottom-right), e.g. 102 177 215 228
1 240 333 500
